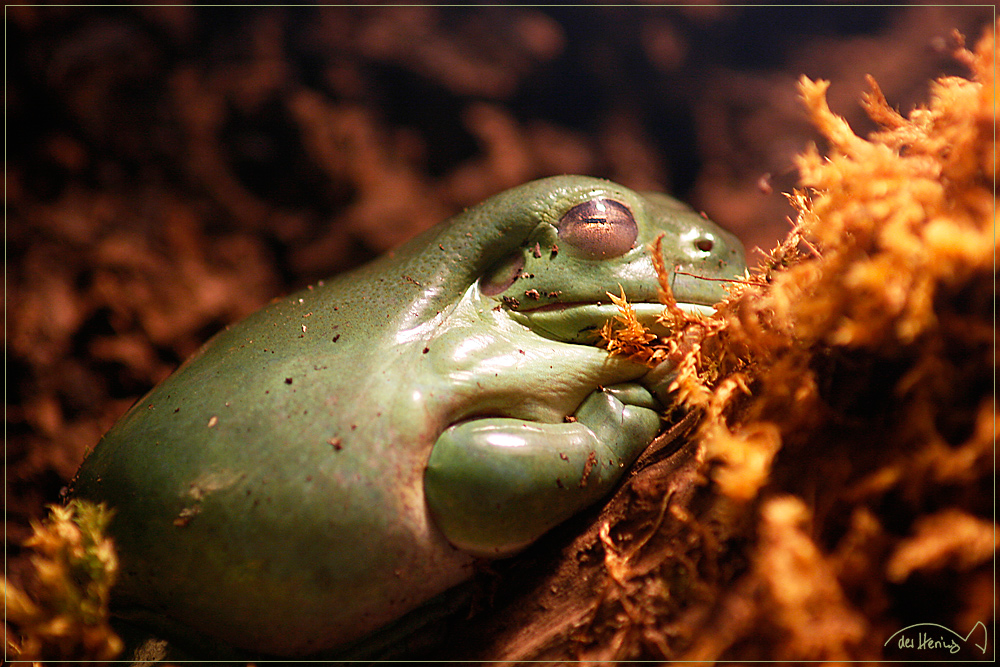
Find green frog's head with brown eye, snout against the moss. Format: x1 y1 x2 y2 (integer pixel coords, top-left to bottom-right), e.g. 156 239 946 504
480 179 746 343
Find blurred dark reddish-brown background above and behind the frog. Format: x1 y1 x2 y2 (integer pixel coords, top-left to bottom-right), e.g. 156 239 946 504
5 5 993 580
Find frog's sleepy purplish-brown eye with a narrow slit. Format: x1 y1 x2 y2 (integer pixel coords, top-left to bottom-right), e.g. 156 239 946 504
558 199 639 259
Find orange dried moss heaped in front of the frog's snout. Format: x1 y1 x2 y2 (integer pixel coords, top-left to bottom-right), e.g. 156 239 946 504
596 19 997 661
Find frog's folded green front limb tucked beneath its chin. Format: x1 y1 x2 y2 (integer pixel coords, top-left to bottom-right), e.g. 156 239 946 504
424 383 660 558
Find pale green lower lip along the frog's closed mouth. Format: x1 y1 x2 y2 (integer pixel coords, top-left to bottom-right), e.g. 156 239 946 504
508 302 715 344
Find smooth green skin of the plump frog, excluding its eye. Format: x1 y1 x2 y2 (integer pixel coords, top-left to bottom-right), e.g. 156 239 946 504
72 176 745 655
